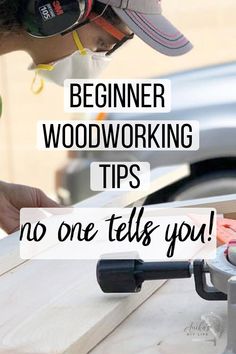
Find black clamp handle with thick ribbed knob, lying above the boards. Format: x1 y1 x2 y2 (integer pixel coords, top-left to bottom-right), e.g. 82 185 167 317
97 259 227 301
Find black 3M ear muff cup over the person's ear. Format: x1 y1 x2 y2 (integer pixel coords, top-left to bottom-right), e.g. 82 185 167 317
19 0 94 38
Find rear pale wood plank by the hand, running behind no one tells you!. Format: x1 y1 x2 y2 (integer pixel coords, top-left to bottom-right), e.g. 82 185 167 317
0 165 189 276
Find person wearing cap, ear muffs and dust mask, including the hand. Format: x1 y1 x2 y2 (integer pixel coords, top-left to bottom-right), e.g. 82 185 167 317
0 0 192 233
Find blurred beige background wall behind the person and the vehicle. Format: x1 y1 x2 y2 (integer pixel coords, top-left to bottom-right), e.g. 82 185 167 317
0 0 236 202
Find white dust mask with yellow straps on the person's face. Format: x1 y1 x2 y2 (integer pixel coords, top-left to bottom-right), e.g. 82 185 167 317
29 31 111 94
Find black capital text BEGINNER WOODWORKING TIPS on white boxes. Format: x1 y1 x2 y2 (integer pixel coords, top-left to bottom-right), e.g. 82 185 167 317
37 79 199 191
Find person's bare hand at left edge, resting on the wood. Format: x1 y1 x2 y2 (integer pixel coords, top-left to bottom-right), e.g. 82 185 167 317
0 181 60 234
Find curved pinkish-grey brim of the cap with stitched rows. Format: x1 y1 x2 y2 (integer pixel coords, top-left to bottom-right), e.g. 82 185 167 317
112 6 193 56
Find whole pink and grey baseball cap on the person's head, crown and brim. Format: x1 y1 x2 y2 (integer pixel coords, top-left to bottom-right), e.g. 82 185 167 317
99 0 193 56
